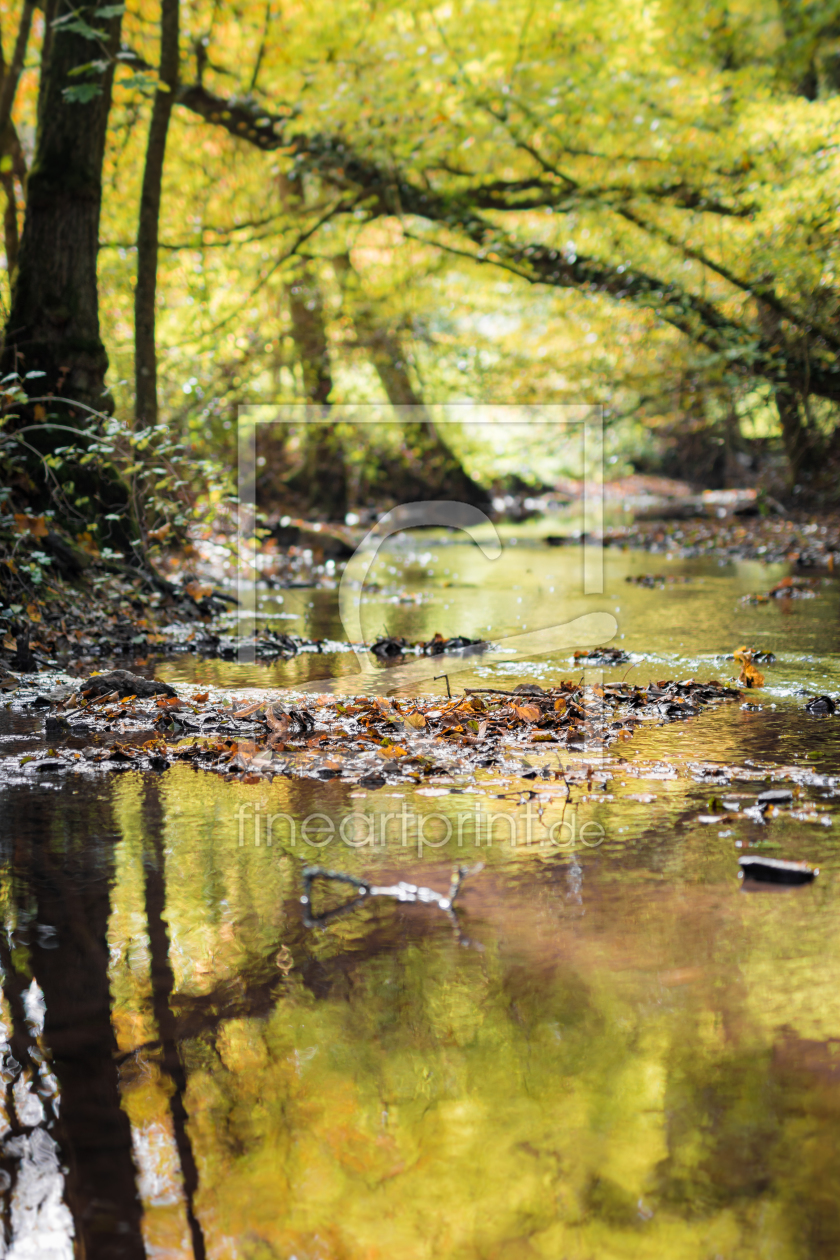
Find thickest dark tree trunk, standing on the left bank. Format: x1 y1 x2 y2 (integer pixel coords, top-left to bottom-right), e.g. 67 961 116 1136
0 0 121 408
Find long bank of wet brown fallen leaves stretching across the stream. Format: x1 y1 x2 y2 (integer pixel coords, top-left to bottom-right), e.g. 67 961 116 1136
14 672 742 786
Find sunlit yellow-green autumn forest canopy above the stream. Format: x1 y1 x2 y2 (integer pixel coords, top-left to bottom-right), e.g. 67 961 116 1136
0 0 840 534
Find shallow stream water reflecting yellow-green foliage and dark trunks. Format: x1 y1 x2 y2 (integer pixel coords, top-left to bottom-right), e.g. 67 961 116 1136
0 544 840 1260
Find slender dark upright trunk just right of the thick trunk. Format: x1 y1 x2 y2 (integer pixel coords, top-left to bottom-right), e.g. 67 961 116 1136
135 0 179 425
